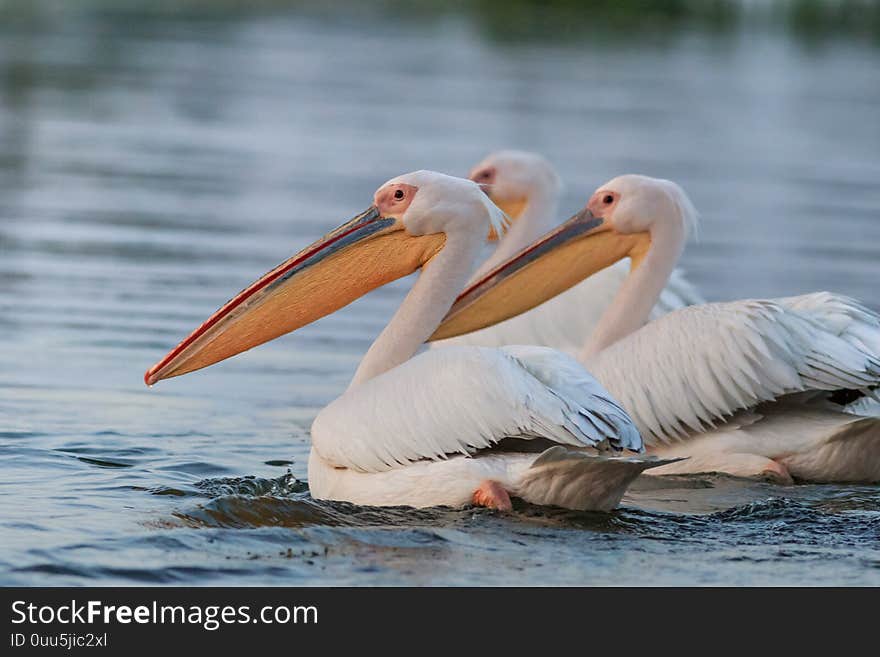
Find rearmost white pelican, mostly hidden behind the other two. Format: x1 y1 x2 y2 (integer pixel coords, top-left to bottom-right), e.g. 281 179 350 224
435 150 704 355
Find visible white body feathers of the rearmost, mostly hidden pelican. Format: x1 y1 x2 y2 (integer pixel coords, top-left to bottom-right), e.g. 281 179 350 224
432 261 703 356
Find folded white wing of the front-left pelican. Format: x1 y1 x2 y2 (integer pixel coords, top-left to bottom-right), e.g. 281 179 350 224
312 347 642 472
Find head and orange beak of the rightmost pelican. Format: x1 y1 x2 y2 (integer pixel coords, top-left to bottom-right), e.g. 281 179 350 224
431 175 697 340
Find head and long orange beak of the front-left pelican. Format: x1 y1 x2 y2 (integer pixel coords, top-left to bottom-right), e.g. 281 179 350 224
144 171 504 385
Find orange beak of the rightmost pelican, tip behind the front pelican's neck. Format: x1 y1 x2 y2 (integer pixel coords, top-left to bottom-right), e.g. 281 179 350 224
430 208 650 340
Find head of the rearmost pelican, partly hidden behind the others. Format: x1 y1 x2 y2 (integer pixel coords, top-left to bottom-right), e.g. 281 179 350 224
469 150 562 233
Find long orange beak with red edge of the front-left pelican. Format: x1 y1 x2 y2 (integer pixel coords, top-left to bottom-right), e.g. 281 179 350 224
144 206 446 385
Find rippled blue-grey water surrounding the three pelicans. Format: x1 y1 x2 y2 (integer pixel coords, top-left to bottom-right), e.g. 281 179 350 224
0 1 880 585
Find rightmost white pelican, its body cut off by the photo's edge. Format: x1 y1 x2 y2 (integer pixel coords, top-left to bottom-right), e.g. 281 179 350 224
433 175 880 482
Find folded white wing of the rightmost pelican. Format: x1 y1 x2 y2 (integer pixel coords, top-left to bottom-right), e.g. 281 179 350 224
587 293 880 444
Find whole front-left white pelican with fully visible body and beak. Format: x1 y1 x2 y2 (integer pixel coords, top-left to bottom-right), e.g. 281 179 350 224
145 171 664 510
